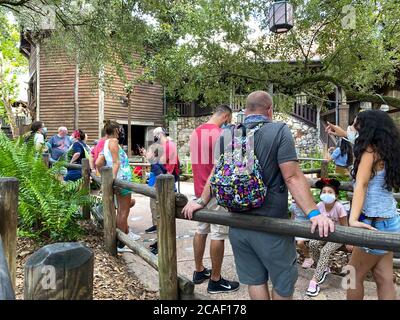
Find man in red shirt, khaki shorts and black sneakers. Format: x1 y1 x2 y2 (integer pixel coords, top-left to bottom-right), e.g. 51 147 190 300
190 105 239 293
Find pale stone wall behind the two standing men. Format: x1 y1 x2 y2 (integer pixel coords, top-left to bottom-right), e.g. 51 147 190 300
177 113 322 162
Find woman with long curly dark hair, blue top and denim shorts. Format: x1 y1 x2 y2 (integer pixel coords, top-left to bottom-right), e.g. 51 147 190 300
347 110 400 300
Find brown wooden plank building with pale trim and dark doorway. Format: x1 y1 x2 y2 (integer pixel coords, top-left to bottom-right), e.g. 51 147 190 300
20 32 165 154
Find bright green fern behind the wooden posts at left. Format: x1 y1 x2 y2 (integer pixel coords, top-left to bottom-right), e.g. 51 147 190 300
0 132 93 241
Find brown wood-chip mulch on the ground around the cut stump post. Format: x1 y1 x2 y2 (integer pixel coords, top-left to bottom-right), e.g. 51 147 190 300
15 221 158 300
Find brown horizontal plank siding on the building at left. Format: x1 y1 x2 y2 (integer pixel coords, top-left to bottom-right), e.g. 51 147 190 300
40 45 164 144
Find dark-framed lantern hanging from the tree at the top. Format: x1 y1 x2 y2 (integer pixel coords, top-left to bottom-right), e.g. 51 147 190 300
268 1 293 33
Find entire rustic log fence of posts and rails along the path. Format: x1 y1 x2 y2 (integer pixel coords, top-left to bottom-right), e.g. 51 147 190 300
0 155 400 300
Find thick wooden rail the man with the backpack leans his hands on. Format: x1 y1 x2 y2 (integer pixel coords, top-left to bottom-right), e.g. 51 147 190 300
176 208 400 252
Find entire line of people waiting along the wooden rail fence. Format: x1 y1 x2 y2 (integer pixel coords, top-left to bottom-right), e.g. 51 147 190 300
25 91 400 300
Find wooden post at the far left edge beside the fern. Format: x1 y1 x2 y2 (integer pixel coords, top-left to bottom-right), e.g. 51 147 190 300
0 178 19 290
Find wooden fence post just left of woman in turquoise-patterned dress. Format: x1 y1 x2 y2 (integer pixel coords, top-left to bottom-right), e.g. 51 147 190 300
101 167 117 256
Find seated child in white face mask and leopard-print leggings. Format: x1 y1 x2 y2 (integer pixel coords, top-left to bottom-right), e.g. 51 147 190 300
306 179 352 297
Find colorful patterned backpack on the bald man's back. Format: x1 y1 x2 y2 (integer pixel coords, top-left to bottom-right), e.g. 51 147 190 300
210 123 267 212
